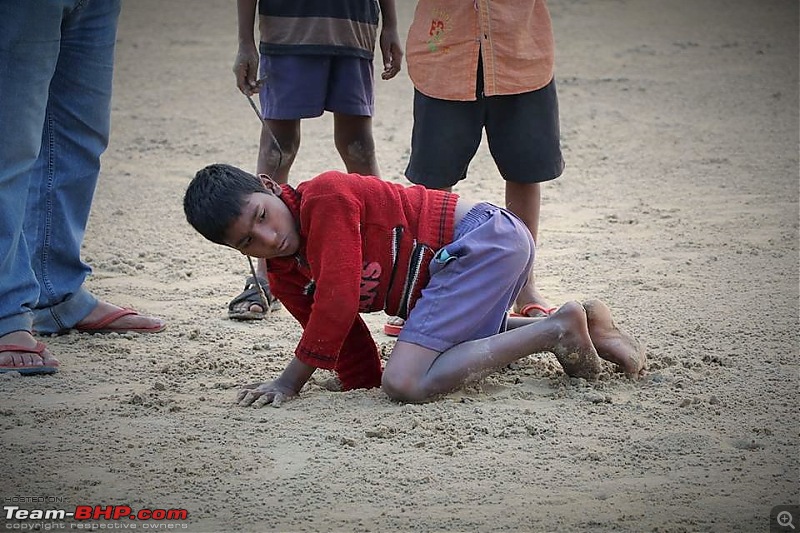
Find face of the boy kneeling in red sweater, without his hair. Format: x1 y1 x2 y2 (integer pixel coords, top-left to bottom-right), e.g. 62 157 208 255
225 181 300 259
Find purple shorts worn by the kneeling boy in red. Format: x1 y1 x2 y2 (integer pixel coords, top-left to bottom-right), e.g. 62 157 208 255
398 203 535 352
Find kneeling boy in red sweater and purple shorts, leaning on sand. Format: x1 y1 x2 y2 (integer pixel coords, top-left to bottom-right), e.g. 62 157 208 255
184 164 644 406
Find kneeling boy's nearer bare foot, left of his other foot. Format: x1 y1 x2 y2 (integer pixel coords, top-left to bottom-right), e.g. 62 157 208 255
548 302 602 379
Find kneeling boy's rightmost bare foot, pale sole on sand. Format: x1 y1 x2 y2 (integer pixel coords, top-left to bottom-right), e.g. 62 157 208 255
583 300 646 377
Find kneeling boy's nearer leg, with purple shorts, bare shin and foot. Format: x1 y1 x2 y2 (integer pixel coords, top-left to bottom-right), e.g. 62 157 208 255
383 204 601 401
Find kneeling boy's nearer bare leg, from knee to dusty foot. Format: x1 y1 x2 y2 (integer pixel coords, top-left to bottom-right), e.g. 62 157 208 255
381 302 601 402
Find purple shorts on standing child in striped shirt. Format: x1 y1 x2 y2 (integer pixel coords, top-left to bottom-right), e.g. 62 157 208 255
259 50 375 120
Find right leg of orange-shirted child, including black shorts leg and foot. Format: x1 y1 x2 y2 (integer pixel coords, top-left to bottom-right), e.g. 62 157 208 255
486 81 564 315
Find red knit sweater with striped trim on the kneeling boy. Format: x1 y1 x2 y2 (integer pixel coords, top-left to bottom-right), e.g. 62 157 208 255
267 171 458 390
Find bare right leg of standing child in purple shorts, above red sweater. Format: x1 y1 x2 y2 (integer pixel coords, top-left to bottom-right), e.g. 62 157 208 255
333 113 381 176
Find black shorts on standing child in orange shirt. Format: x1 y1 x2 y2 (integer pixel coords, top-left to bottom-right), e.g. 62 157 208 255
406 75 564 189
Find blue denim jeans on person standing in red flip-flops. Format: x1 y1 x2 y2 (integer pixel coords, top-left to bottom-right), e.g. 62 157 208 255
0 0 120 335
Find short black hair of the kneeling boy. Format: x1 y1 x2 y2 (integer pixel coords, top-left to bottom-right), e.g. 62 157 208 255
183 163 268 244
